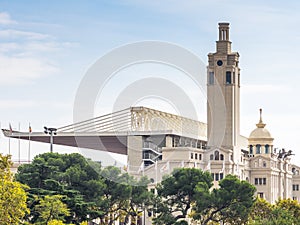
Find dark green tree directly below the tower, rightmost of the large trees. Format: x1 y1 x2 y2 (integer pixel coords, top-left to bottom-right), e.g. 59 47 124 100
193 175 255 225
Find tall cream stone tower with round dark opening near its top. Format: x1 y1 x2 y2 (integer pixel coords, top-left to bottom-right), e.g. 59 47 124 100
207 23 241 162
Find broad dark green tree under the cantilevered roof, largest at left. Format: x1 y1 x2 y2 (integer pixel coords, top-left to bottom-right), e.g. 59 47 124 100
16 153 104 224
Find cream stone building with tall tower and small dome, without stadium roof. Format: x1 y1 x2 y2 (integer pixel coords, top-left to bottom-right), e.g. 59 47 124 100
143 23 300 206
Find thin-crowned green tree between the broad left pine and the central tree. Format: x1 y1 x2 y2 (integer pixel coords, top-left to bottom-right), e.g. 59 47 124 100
98 166 151 224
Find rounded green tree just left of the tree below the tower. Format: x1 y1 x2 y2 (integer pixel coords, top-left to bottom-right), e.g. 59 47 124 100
152 168 212 225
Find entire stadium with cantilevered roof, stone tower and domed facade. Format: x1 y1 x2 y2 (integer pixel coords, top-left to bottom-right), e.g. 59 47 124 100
4 23 300 206
